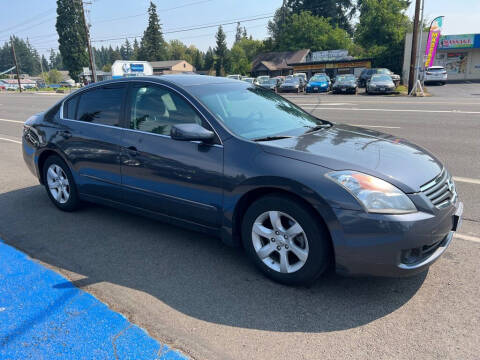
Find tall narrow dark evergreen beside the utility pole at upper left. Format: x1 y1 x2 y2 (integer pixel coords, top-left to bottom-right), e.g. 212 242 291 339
55 0 88 82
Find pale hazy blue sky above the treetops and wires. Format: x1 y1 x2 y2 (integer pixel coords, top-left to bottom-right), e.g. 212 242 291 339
0 0 480 54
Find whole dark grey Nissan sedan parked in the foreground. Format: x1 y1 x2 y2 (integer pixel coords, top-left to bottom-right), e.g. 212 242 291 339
22 75 463 285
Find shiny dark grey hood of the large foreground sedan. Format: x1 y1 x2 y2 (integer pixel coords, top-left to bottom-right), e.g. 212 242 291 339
260 124 443 193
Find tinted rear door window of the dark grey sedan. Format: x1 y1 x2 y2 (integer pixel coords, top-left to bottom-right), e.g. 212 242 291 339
76 84 125 126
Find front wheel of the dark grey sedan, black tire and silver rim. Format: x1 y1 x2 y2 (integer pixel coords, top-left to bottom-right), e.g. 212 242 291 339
242 195 331 285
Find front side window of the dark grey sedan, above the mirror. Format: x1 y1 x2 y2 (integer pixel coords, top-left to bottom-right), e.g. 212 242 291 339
130 84 204 135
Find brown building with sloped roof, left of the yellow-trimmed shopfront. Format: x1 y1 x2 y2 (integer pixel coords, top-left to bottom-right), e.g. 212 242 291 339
251 49 310 77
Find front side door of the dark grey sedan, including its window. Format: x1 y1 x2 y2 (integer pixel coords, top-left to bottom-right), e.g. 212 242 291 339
121 83 223 226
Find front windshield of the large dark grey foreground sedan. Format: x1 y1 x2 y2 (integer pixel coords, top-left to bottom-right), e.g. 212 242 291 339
190 83 325 140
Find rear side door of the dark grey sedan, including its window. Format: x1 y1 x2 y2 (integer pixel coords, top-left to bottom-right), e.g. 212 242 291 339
58 83 126 201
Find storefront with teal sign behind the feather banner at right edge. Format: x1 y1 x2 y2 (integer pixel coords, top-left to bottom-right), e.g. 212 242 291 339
403 32 480 81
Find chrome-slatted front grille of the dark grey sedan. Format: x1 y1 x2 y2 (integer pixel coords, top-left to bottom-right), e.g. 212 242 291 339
420 169 457 209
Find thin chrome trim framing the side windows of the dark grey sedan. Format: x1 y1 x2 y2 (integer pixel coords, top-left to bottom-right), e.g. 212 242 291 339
60 80 223 148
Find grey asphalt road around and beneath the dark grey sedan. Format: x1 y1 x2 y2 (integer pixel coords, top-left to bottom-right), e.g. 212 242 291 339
0 84 480 360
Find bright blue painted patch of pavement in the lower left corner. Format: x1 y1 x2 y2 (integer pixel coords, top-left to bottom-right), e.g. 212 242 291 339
0 239 188 360
